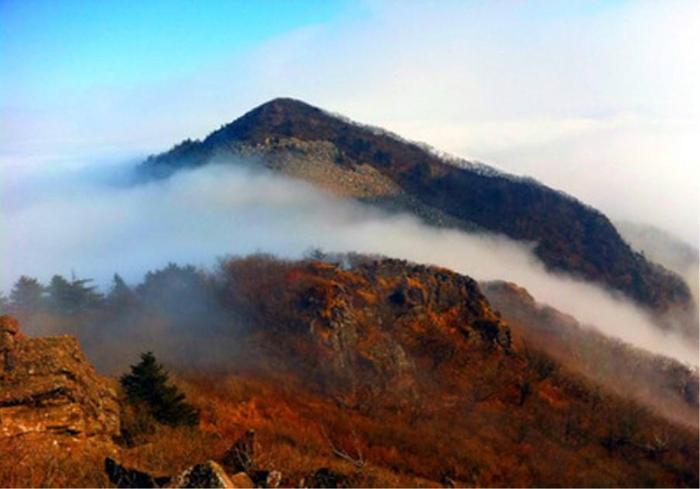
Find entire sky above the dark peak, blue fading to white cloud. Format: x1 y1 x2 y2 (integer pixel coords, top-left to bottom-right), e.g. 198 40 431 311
0 0 700 242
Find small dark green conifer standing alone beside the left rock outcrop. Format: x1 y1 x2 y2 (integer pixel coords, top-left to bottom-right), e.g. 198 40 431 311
120 352 199 426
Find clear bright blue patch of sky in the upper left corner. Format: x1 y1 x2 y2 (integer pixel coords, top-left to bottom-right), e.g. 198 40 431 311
0 0 357 97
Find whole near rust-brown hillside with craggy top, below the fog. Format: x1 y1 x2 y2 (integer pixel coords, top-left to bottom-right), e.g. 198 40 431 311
0 255 698 487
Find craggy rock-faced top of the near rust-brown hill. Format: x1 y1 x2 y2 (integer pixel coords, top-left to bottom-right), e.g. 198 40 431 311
224 255 511 400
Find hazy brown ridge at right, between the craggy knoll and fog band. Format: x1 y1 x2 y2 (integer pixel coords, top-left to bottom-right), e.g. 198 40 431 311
480 282 698 427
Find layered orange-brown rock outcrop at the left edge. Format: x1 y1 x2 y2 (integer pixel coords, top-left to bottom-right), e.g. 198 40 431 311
0 316 119 442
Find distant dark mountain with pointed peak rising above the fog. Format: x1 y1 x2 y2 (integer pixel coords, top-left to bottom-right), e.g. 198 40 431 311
140 99 691 311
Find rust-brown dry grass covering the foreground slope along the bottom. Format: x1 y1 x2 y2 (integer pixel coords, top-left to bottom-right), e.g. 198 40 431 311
0 364 697 487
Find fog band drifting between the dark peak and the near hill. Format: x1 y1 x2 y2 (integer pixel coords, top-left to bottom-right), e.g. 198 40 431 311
0 162 698 365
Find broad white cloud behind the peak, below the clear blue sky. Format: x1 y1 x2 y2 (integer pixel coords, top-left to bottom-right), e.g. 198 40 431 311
0 1 700 244
